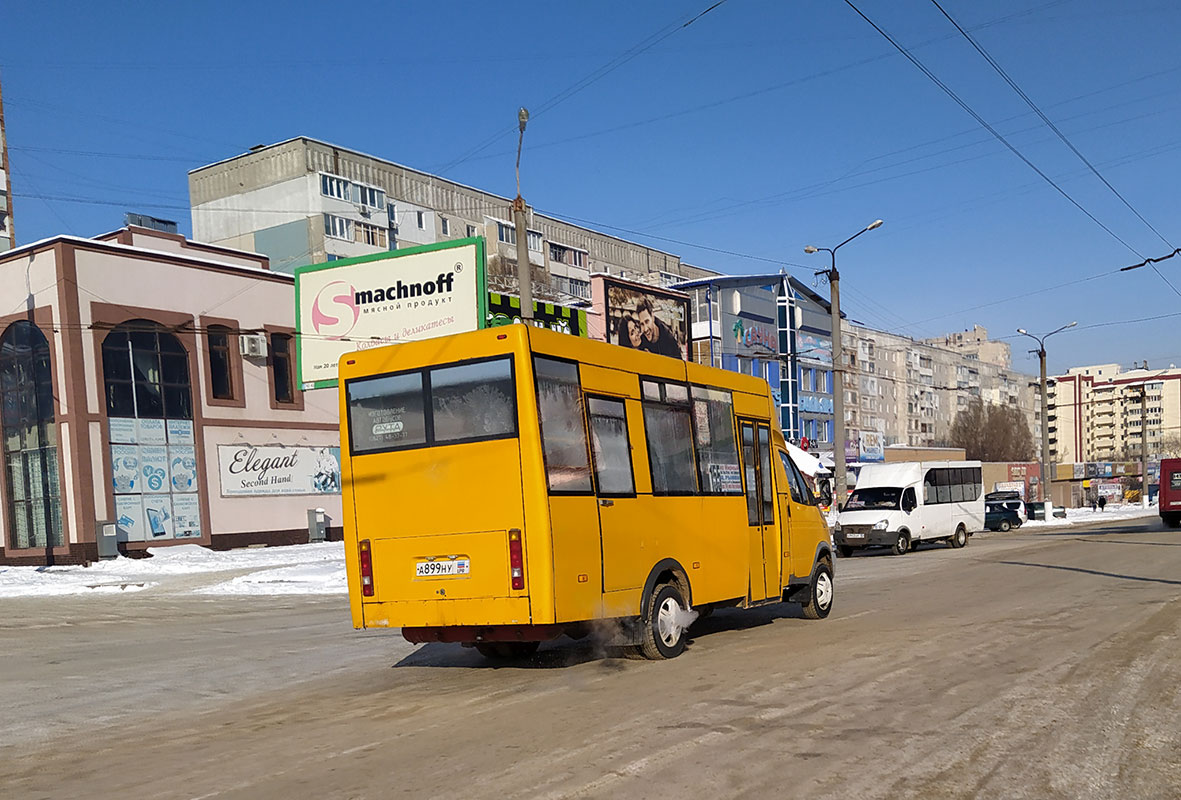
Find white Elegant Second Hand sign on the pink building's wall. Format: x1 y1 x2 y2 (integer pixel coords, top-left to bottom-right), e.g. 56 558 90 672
217 444 340 497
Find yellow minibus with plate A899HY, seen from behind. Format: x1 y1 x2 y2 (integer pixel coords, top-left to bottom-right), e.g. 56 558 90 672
340 325 834 658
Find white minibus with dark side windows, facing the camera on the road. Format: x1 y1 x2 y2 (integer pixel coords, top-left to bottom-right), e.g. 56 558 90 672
833 461 984 555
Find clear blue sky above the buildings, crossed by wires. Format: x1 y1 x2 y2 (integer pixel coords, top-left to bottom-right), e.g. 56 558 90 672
0 0 1181 372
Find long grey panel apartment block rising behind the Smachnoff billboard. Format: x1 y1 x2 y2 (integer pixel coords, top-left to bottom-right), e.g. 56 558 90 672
189 137 715 305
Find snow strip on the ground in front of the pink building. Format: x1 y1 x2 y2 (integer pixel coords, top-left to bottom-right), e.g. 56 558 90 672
0 541 347 598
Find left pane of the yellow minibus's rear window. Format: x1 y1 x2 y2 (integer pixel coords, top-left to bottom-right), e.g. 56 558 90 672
346 372 426 455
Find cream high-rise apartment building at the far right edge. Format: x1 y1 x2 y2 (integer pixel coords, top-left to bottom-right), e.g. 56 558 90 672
1048 364 1181 463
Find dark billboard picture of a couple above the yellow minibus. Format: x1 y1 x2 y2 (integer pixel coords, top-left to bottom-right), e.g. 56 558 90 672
603 279 690 360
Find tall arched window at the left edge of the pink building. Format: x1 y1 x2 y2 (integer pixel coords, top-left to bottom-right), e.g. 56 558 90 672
0 320 64 549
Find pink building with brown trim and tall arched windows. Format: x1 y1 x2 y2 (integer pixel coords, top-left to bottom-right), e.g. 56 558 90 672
0 220 340 564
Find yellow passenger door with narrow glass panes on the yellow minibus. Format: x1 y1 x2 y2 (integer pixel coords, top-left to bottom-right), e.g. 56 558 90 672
738 419 782 600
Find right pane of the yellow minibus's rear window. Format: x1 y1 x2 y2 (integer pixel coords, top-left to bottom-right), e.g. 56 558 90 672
431 358 516 444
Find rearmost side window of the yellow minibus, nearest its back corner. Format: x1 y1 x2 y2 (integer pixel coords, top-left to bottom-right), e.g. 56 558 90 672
533 357 591 493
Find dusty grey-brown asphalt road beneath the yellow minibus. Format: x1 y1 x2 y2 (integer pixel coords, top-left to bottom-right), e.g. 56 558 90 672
0 520 1181 800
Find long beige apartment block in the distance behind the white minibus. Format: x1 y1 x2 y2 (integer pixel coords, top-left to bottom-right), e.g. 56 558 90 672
842 324 1042 447
